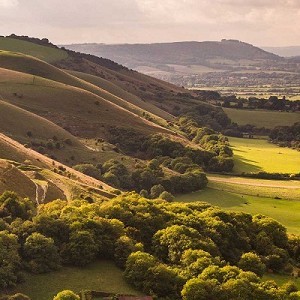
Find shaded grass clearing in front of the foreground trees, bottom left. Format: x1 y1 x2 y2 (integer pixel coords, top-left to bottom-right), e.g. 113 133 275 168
8 260 141 300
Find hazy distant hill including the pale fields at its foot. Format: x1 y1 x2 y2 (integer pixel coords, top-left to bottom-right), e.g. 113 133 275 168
64 40 284 86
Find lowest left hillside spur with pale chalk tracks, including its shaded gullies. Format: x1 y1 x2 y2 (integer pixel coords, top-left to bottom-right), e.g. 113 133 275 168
0 133 113 201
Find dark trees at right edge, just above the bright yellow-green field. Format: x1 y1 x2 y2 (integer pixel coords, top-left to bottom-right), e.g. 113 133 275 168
269 122 300 150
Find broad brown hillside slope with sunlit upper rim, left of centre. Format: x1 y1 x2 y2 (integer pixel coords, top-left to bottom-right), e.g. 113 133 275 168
0 69 167 138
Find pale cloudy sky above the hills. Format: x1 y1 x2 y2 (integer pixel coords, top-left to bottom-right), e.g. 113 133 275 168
0 0 300 46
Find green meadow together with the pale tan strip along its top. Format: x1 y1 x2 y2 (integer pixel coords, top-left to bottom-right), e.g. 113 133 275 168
176 178 300 234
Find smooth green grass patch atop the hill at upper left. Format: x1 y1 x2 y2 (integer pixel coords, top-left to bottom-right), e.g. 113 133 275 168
0 37 68 63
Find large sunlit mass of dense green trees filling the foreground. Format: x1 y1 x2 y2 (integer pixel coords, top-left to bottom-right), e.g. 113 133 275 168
0 192 300 300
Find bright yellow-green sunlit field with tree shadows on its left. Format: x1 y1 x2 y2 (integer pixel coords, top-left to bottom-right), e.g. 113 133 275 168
229 137 300 173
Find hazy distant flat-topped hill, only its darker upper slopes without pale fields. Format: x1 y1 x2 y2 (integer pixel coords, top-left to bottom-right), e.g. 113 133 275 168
64 40 279 67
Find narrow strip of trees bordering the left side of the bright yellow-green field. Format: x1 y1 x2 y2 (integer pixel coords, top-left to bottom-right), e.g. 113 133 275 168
178 116 234 172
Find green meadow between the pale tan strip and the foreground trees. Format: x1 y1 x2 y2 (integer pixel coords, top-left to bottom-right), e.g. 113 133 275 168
176 183 300 234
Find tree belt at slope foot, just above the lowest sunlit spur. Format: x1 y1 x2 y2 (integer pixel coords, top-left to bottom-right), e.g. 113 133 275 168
74 157 207 197
